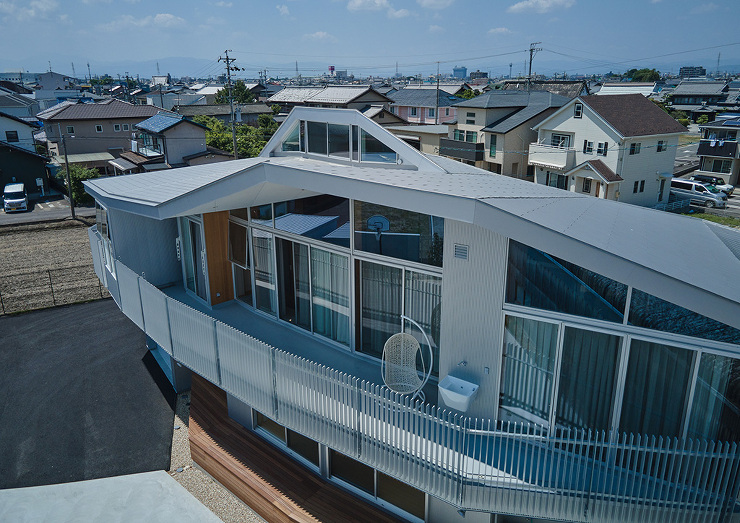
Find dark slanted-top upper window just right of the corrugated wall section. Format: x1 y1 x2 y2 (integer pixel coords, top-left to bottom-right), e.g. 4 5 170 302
506 240 627 323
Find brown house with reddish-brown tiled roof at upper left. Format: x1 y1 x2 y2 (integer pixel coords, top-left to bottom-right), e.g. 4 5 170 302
37 98 160 157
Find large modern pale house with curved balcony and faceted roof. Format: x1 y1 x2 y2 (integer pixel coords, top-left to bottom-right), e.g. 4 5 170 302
85 106 740 523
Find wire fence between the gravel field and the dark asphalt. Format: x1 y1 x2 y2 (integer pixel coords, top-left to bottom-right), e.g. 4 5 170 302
0 264 110 314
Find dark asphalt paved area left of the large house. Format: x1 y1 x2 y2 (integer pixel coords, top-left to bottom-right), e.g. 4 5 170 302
0 299 174 489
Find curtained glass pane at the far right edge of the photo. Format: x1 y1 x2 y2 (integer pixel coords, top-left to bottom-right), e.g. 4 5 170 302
688 354 740 441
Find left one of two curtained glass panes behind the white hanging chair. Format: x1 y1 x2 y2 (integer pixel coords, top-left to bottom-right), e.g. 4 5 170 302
359 261 403 358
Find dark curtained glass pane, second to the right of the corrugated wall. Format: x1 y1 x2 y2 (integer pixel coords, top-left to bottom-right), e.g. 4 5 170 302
556 327 622 430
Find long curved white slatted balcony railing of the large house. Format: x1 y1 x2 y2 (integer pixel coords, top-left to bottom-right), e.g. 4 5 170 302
90 228 740 523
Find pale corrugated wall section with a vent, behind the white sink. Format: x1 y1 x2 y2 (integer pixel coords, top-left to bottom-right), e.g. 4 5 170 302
439 220 507 417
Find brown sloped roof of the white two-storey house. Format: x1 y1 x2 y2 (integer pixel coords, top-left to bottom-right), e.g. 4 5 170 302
579 94 688 138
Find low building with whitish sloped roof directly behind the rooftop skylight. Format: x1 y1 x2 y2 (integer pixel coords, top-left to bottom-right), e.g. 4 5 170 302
267 85 391 112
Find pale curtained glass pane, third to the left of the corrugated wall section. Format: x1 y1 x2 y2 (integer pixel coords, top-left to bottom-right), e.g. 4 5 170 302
311 247 349 346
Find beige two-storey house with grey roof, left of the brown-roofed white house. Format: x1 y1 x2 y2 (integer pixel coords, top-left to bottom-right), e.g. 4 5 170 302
439 89 568 181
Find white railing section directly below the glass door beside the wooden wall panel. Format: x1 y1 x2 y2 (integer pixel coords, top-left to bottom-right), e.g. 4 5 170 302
167 298 221 385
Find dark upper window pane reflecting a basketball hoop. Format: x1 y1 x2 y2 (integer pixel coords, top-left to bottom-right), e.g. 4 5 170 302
355 200 444 267
